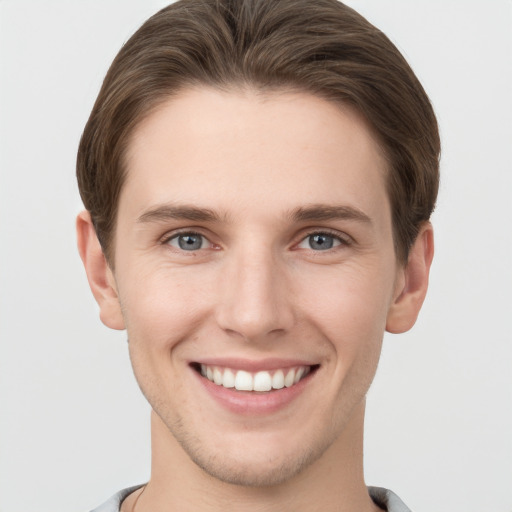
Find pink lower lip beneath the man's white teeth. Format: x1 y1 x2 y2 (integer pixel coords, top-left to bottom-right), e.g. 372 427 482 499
192 370 316 415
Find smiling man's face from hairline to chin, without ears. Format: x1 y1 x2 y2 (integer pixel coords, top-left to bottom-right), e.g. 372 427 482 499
107 89 402 485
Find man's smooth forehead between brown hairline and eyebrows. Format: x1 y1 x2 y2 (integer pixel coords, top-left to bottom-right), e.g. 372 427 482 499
119 88 389 227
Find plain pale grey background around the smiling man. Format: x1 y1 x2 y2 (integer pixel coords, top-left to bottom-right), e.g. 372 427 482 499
0 0 512 512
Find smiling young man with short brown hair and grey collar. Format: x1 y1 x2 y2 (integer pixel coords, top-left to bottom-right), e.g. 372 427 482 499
77 0 439 512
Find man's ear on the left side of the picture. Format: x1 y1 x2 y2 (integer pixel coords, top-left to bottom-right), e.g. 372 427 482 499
76 211 125 330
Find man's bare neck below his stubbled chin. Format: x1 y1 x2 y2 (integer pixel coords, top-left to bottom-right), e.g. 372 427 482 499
137 403 379 512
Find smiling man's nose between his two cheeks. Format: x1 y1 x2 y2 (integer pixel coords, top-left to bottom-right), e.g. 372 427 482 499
216 248 295 342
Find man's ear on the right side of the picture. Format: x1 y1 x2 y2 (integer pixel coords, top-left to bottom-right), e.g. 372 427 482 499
386 222 434 333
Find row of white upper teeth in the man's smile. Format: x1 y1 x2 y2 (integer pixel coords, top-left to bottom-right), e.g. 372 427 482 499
200 364 311 392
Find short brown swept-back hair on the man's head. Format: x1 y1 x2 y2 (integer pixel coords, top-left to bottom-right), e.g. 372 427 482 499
77 0 440 264
